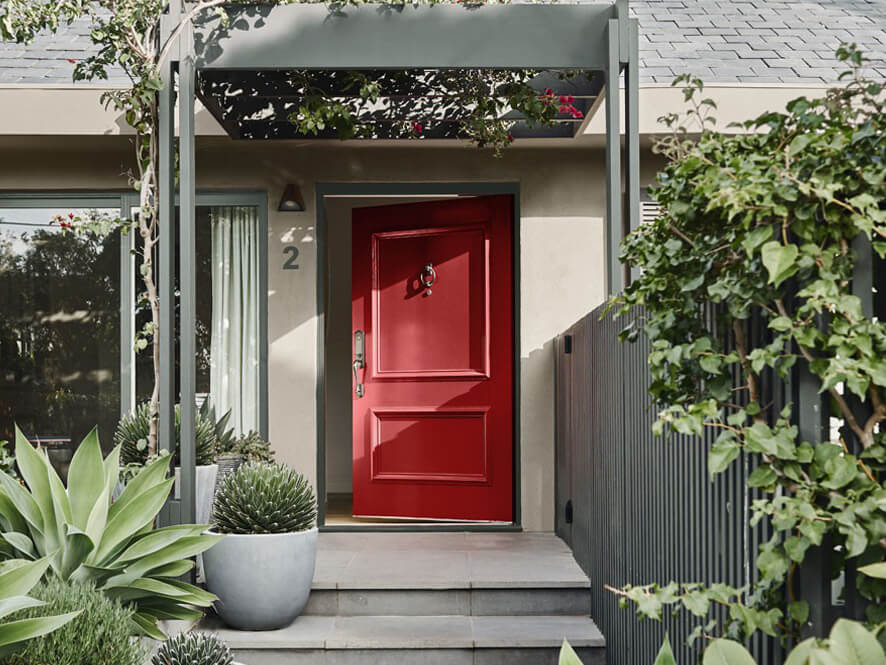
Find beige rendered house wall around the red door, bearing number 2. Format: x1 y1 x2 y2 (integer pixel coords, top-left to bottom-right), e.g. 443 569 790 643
0 136 664 530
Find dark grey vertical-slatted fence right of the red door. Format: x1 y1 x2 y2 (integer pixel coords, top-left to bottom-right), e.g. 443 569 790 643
556 310 781 665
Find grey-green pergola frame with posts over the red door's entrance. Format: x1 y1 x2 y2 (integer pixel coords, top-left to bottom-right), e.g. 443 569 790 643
159 0 640 523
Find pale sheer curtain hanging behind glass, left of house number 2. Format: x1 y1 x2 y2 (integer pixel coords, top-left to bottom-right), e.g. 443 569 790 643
209 206 261 433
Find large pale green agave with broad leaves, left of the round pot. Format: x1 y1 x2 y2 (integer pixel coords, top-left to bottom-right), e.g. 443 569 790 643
0 428 224 639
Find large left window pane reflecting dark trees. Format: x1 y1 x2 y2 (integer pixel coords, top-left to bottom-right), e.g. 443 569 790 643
0 198 120 447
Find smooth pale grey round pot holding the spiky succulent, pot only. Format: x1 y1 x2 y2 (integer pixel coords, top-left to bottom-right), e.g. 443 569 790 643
203 527 317 630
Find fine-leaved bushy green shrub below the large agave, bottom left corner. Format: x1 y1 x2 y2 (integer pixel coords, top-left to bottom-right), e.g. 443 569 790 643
3 575 148 665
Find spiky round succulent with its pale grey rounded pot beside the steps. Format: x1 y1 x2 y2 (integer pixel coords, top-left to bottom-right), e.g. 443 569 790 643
203 462 317 630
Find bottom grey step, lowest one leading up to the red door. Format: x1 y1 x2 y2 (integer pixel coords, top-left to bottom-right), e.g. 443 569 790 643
199 615 605 665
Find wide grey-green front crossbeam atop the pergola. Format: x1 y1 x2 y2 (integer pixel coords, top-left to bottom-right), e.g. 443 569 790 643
195 4 615 70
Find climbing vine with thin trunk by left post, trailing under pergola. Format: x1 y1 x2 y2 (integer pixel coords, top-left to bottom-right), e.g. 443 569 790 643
0 0 581 454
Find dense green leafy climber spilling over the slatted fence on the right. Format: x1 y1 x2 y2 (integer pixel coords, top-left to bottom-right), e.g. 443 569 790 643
611 46 886 640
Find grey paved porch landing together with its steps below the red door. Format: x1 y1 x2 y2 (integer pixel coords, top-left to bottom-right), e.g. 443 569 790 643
201 533 605 665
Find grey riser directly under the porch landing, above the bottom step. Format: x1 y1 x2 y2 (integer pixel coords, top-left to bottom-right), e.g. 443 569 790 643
304 586 591 616
